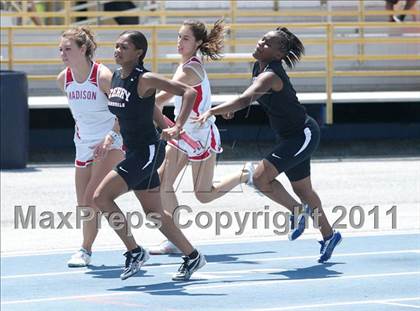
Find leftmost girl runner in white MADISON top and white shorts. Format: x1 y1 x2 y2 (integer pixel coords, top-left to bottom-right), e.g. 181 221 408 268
57 27 124 267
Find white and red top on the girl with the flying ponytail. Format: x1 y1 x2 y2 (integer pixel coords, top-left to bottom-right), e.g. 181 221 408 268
174 56 216 130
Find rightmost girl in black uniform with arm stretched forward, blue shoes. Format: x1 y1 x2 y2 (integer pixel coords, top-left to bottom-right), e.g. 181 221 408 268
198 28 341 262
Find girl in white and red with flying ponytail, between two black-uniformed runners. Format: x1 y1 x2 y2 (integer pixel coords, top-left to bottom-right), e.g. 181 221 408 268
149 20 252 254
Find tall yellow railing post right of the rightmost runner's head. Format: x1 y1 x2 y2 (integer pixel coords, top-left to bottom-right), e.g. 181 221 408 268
325 23 334 124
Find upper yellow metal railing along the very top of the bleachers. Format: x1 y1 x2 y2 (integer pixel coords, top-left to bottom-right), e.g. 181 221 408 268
2 0 420 26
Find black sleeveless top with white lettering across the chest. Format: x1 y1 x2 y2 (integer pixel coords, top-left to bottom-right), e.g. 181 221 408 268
108 66 159 149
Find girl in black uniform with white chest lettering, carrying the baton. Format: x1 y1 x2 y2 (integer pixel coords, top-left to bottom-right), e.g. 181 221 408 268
94 31 206 281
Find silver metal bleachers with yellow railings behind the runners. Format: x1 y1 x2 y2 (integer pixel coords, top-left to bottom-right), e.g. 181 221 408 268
1 0 420 123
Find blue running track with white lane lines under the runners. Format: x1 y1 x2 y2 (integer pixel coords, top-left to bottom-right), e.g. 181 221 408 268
1 233 420 311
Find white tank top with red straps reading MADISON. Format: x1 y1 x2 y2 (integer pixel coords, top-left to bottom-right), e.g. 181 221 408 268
64 63 115 140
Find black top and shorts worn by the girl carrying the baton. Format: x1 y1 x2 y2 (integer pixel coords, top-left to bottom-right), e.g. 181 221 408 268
108 66 165 190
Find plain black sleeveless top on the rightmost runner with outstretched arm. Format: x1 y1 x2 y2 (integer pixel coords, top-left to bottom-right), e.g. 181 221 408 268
252 61 306 137
